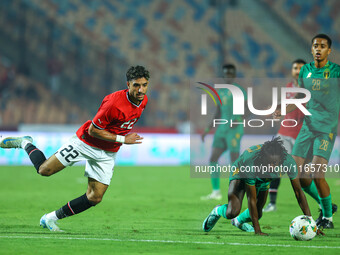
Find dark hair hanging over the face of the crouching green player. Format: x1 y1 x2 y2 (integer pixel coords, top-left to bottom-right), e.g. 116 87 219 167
255 136 287 166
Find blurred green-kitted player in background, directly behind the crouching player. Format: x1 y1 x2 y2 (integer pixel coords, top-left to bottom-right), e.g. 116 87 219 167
201 64 246 200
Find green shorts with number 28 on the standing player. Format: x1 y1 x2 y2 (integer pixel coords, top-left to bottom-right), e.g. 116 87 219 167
292 124 335 160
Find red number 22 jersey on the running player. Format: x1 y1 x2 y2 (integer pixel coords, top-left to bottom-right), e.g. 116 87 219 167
77 89 148 152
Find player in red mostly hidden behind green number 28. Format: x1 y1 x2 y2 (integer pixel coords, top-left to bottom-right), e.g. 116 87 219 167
263 59 306 212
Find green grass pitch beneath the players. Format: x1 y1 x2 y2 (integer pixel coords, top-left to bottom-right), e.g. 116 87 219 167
0 166 340 255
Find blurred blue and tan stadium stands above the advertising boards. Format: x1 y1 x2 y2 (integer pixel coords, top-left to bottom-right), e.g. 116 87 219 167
0 0 340 133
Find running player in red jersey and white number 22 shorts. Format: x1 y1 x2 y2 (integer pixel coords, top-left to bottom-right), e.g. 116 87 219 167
0 66 150 231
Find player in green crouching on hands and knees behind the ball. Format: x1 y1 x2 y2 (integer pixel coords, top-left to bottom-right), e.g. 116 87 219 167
203 137 320 235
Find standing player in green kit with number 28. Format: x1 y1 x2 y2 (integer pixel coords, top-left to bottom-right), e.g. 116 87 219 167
274 34 340 229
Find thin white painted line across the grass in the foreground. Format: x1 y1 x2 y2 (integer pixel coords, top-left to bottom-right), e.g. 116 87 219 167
0 236 340 249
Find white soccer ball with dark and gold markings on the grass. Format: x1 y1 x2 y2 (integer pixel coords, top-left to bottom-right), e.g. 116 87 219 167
289 215 318 241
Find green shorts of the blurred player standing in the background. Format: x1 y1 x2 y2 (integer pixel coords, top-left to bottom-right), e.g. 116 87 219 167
212 127 243 153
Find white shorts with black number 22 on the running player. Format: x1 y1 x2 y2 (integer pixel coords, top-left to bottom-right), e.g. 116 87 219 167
55 136 117 185
